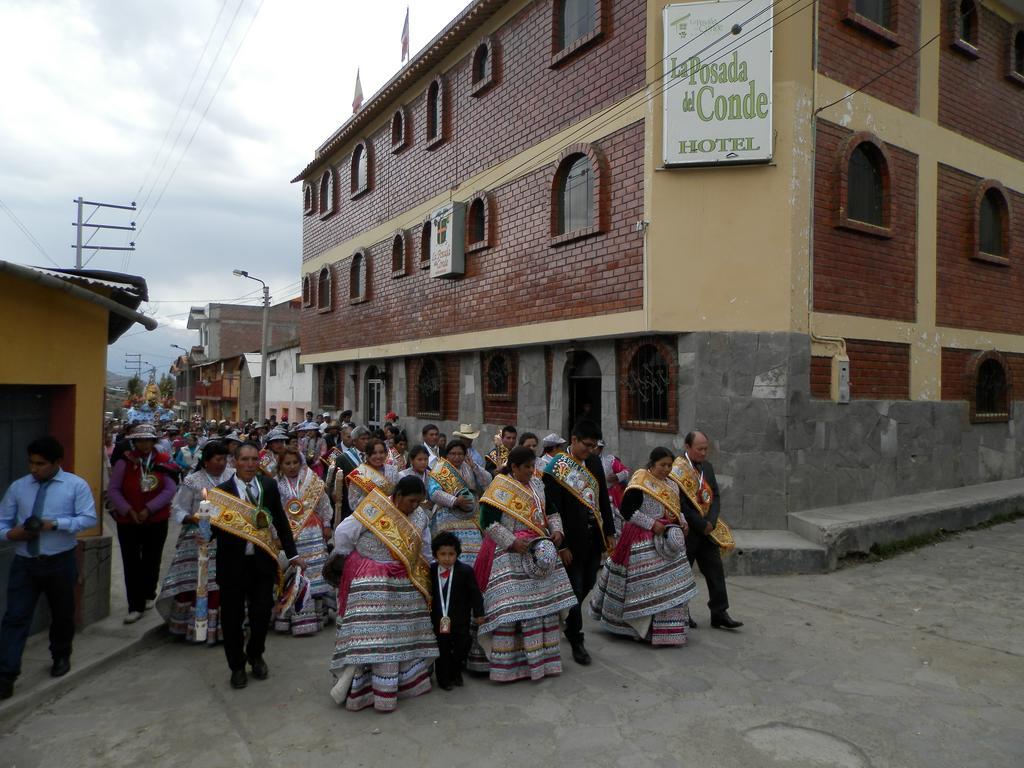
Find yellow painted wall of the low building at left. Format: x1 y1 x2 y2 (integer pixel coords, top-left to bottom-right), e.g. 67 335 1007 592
0 274 108 536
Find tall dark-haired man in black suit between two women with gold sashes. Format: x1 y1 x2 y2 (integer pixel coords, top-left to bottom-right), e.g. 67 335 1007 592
544 420 615 665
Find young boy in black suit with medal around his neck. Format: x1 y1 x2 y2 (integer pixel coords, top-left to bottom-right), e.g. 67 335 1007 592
430 530 483 690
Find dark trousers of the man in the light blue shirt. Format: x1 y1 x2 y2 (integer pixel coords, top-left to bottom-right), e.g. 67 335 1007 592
0 549 78 680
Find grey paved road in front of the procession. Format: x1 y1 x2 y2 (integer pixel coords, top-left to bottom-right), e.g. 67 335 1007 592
0 521 1024 768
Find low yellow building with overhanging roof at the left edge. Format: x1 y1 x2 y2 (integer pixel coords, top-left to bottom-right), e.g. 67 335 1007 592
0 261 157 624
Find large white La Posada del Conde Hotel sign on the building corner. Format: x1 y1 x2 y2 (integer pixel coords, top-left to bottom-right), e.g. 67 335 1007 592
663 0 773 166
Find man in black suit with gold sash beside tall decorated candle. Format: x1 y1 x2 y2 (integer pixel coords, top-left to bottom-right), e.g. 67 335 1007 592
213 442 301 688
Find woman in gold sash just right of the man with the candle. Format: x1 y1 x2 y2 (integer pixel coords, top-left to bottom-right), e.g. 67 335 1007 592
273 449 336 637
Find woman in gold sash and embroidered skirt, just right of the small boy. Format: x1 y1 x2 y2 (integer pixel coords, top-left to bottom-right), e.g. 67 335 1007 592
468 446 577 682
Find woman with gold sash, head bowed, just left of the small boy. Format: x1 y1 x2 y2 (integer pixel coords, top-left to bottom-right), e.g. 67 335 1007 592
328 477 438 712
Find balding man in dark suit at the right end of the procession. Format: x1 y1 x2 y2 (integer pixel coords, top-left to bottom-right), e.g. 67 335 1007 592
680 432 743 630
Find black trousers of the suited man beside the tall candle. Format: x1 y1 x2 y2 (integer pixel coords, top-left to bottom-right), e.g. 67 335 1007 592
217 555 276 672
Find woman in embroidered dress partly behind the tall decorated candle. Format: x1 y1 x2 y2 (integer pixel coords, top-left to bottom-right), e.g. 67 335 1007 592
156 440 234 645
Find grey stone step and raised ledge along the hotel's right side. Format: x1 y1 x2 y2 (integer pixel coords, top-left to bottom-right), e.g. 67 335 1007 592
723 478 1024 575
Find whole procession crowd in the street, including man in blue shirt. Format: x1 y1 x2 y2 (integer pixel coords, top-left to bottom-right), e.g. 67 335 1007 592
0 412 741 712
